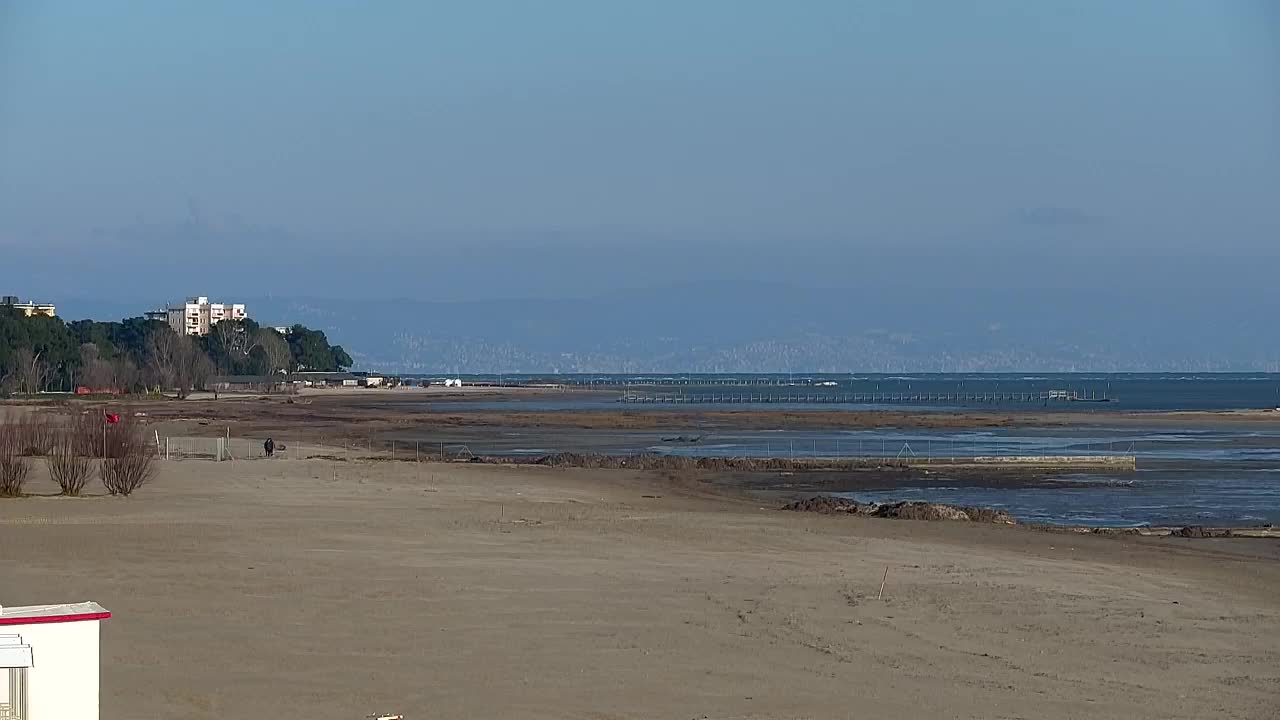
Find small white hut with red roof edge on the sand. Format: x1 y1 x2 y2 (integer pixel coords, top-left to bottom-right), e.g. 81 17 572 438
0 602 111 720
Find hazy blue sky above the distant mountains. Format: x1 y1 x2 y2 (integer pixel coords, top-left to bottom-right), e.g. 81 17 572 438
0 0 1280 301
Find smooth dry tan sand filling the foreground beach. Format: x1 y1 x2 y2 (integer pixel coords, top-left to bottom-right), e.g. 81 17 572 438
0 450 1280 720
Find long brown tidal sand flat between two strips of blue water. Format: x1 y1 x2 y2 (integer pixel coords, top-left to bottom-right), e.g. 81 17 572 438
102 388 1280 439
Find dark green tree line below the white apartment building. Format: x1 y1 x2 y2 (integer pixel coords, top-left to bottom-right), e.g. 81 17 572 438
0 307 352 397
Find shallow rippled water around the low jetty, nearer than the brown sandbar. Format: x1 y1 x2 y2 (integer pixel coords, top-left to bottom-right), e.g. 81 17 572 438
381 424 1280 527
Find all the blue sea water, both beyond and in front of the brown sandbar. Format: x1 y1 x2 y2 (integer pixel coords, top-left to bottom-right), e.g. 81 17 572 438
412 373 1280 527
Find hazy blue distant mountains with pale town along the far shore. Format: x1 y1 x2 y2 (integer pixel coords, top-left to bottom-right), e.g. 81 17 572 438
60 283 1280 373
